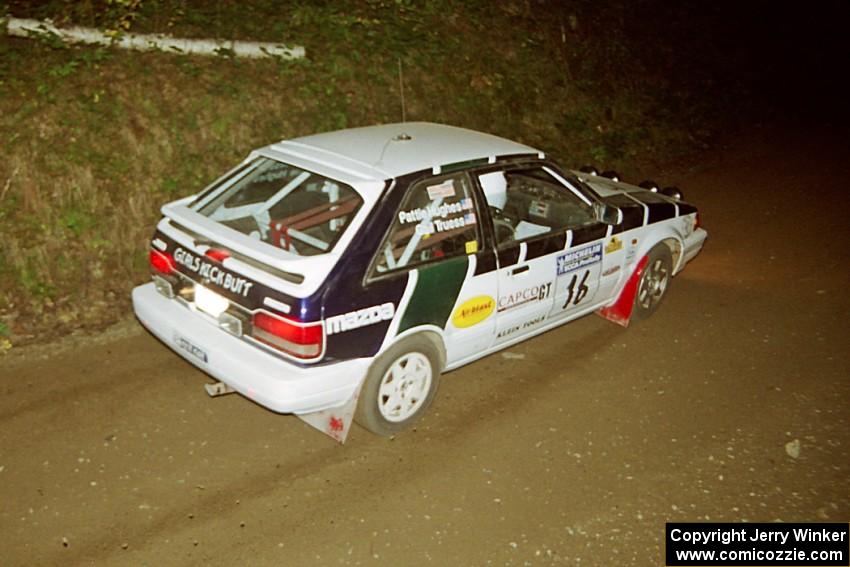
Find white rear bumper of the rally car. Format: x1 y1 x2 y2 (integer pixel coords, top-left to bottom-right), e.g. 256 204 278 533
133 283 371 414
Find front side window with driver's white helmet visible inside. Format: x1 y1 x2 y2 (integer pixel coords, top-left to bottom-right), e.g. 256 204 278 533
478 166 596 247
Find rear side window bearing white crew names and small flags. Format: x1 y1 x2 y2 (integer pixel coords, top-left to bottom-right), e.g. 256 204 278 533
373 174 479 274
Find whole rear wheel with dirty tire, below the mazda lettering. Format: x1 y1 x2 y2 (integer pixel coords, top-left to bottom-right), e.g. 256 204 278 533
354 335 441 437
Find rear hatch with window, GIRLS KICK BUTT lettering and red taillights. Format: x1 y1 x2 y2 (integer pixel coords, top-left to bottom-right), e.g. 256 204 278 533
150 156 372 361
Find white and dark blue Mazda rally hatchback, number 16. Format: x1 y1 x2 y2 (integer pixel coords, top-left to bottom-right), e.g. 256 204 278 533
133 123 706 441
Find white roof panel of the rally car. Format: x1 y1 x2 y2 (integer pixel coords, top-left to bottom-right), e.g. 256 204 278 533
269 122 542 179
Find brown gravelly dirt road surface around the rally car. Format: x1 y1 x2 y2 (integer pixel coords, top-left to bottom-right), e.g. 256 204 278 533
0 122 850 566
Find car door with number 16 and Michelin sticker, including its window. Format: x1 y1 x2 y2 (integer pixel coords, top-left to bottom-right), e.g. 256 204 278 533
477 162 608 345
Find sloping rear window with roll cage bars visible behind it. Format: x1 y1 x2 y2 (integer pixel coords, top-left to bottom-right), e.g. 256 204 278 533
191 157 363 256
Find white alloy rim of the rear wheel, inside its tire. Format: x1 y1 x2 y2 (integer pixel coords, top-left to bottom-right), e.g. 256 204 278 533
378 352 433 423
